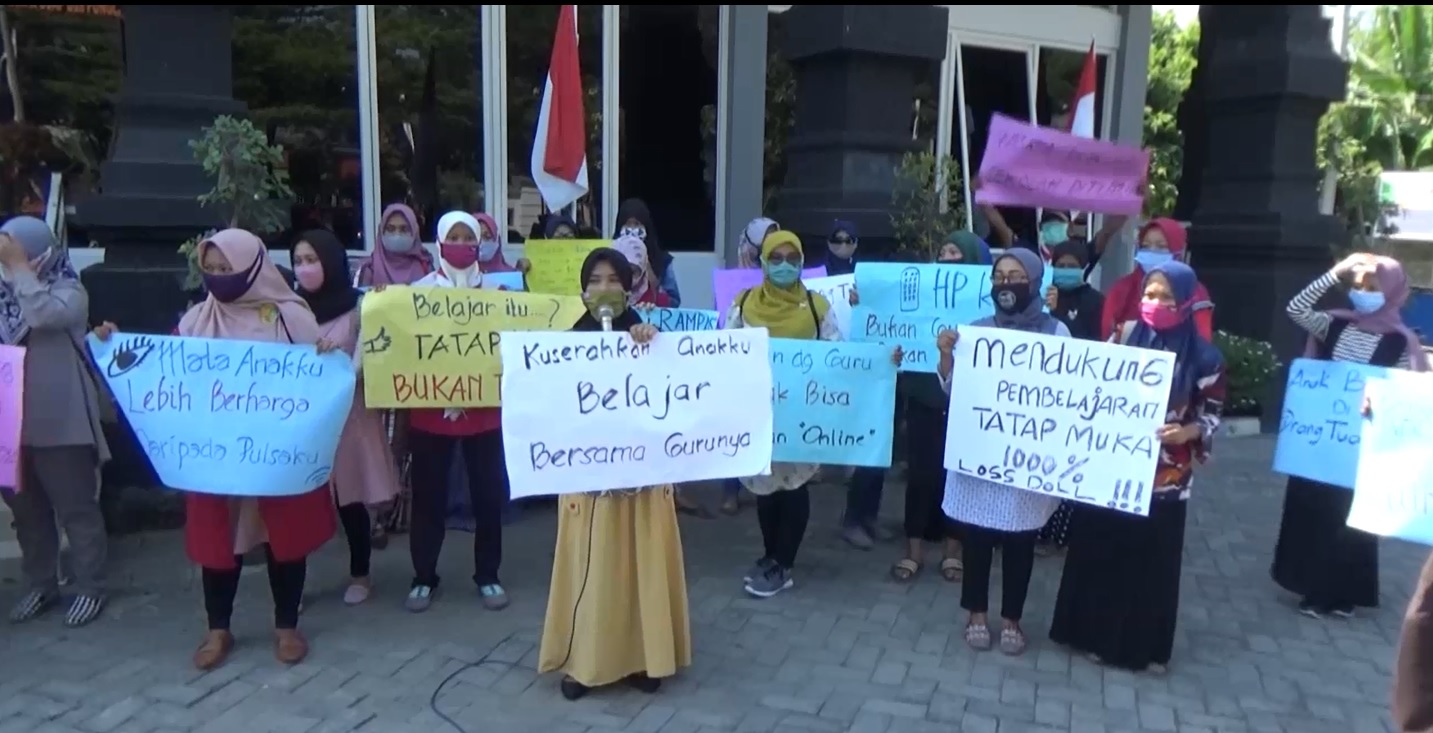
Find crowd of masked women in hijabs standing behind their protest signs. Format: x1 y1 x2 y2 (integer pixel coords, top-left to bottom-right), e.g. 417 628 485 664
0 193 1427 699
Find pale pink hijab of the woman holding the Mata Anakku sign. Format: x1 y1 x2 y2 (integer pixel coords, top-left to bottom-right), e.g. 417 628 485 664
179 229 320 344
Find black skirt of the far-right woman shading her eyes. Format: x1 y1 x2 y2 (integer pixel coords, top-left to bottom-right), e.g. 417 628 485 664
1270 477 1379 610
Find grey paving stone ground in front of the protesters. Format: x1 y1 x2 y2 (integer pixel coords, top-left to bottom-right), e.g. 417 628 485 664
0 438 1424 733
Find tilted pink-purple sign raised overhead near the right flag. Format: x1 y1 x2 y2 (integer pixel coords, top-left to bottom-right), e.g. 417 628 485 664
976 115 1149 215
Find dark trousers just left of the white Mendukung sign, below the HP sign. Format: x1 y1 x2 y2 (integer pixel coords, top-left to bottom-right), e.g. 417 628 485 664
906 399 954 543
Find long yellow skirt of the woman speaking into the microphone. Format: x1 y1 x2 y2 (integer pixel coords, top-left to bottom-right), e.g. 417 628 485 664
537 484 692 687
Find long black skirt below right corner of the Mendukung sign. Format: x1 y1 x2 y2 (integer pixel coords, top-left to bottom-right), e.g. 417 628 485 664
1050 500 1188 671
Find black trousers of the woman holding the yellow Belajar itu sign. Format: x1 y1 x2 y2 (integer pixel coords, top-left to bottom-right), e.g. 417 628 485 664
408 429 507 587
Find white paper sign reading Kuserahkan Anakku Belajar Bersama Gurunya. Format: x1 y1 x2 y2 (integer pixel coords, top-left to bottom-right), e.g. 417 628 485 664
502 328 771 498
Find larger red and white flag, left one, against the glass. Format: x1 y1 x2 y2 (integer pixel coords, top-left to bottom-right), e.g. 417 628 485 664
532 6 588 210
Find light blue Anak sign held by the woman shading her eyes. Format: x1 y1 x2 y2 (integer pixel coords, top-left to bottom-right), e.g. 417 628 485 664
1274 359 1387 488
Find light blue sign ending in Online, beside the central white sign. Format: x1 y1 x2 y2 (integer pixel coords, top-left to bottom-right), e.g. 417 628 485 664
771 338 896 468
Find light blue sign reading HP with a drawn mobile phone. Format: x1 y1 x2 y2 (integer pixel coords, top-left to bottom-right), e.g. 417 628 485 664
851 262 1053 372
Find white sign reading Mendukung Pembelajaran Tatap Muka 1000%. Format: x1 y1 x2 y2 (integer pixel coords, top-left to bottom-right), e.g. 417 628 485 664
946 326 1174 515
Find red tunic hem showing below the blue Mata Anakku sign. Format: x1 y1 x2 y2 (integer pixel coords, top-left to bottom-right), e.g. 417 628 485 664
183 484 338 570
